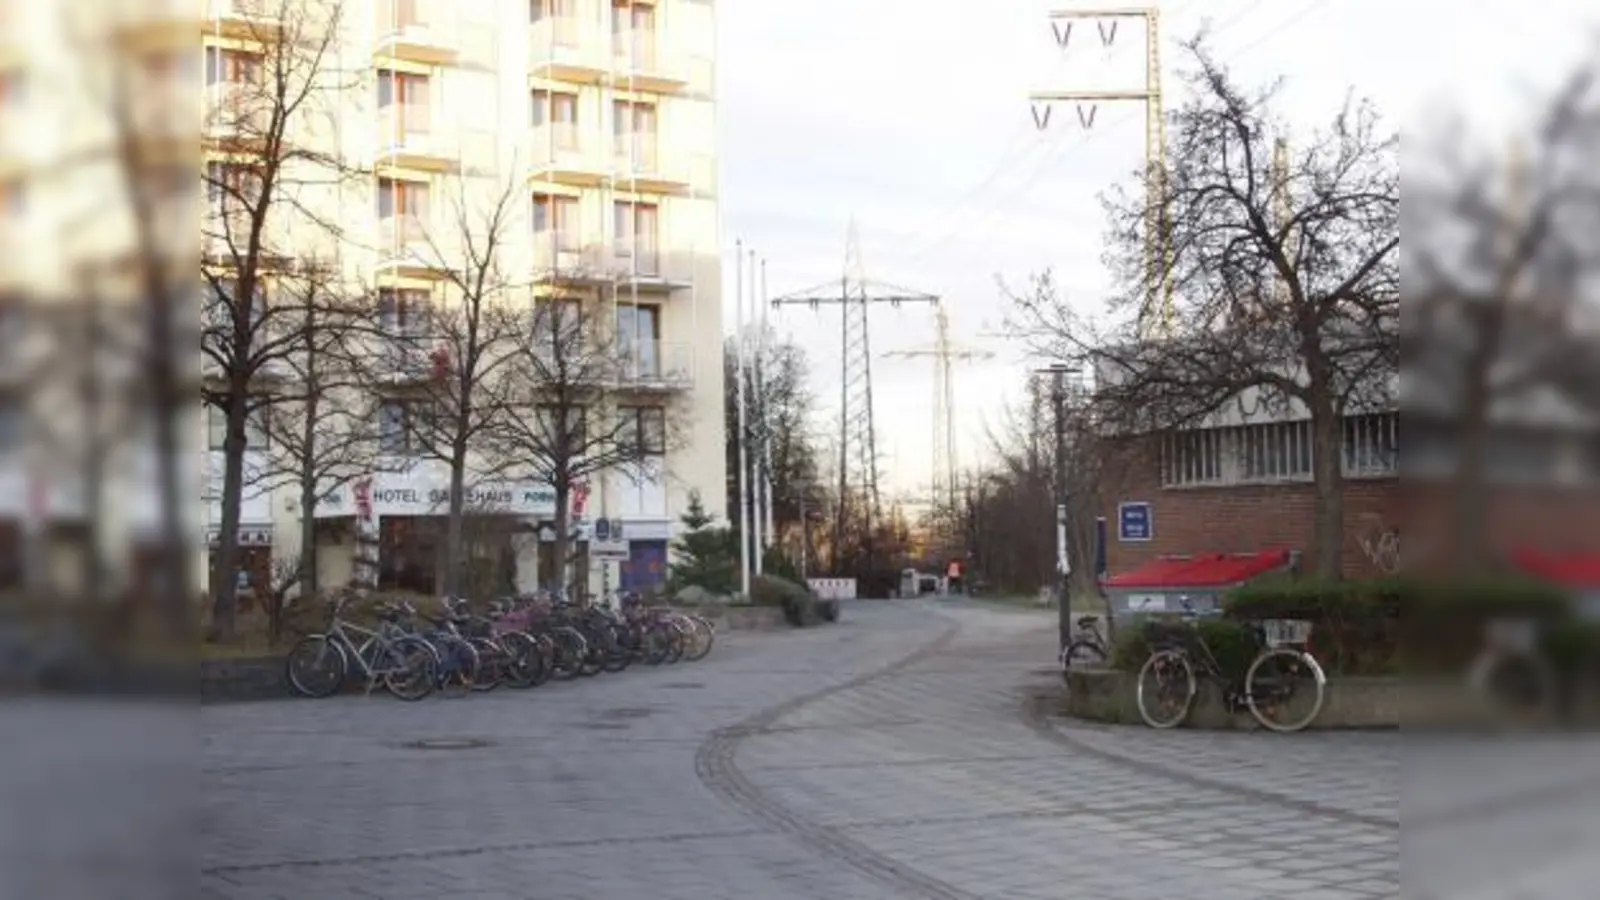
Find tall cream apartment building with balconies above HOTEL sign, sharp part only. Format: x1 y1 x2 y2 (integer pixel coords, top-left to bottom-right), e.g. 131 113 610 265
202 0 725 602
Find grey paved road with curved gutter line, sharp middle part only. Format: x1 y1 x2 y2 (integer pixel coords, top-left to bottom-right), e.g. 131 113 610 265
190 604 1414 900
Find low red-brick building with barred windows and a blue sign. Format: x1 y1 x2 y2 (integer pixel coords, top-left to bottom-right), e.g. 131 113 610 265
1101 412 1600 578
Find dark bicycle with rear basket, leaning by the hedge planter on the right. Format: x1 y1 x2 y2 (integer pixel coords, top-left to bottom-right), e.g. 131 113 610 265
1136 599 1328 732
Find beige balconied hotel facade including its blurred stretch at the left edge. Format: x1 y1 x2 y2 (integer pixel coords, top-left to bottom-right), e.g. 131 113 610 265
0 0 725 602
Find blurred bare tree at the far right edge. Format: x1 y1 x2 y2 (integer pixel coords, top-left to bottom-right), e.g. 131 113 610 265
1402 61 1600 573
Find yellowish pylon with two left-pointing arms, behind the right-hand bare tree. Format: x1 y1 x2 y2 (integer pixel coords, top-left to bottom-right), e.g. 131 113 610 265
1029 6 1174 336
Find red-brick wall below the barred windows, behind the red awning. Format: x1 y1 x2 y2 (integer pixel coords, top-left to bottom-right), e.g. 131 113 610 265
1101 432 1600 578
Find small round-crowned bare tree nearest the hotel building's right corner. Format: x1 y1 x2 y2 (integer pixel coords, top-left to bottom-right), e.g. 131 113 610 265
496 283 685 589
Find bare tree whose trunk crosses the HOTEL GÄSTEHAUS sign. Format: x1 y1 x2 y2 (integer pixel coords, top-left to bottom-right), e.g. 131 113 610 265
388 173 528 596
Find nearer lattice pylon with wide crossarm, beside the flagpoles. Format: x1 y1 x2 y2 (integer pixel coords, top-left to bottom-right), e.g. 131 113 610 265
771 219 939 573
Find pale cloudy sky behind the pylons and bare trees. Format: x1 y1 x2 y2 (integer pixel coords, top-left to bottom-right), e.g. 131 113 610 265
718 0 1594 496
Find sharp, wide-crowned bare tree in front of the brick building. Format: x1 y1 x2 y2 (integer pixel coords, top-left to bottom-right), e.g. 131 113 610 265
1014 38 1400 577
